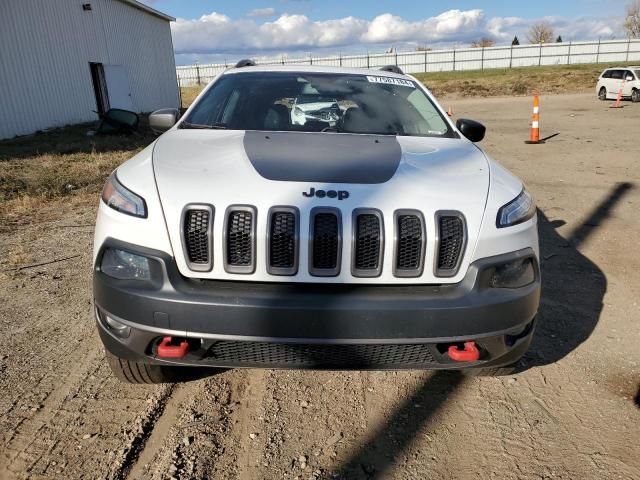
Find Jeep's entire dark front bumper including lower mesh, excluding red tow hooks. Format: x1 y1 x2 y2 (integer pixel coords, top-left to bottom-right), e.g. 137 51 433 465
93 240 540 369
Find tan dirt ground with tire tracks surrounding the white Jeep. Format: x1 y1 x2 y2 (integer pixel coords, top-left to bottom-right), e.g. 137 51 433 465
0 94 640 480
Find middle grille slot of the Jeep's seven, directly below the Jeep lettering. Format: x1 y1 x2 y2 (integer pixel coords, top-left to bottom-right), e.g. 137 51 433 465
310 209 342 276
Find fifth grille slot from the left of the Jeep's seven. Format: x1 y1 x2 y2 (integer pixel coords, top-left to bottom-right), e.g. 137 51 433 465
352 211 383 277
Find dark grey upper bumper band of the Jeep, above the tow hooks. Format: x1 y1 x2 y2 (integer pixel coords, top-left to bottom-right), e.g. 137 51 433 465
93 240 540 343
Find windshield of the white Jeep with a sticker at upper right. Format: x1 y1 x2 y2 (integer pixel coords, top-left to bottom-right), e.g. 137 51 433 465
181 72 455 137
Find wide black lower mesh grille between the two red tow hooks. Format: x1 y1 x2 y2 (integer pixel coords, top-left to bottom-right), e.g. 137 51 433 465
207 340 435 368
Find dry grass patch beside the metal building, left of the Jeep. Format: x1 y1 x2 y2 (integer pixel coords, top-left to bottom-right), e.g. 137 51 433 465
0 120 155 224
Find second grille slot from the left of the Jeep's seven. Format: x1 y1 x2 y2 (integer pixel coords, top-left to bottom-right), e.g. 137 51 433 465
225 207 255 273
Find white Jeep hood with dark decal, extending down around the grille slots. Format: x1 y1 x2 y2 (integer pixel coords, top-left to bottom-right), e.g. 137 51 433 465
153 130 489 283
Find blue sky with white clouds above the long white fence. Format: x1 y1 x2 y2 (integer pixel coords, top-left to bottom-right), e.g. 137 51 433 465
143 0 624 65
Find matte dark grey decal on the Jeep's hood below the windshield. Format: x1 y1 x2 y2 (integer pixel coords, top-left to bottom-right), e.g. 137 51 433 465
244 131 402 183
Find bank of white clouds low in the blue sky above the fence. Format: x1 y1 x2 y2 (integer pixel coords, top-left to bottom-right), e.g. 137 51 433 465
172 9 619 57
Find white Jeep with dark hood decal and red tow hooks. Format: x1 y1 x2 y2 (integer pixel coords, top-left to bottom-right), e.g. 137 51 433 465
94 62 540 382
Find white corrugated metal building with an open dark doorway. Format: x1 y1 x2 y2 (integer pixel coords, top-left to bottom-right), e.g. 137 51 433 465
0 0 179 138
